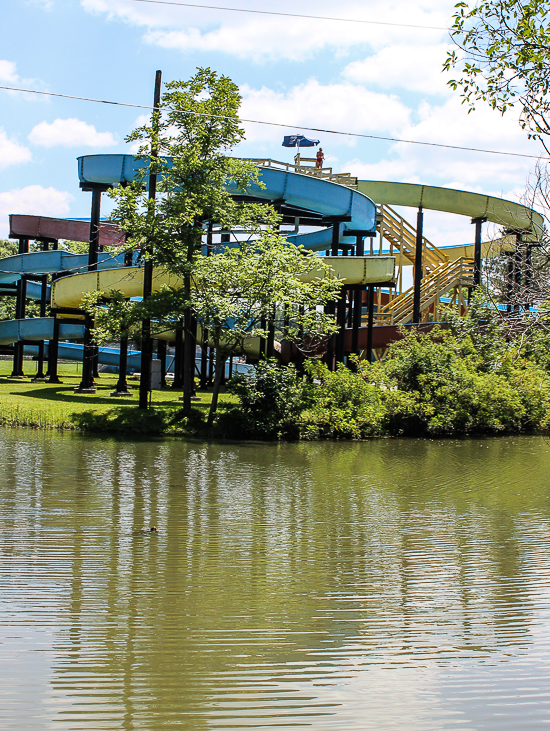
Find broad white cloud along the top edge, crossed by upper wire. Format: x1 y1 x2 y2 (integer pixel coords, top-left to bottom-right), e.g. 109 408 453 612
81 0 453 61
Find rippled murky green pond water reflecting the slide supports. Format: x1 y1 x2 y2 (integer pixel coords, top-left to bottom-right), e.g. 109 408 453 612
0 430 550 731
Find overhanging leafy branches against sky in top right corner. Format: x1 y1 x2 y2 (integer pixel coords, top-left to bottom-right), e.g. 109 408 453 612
444 0 550 138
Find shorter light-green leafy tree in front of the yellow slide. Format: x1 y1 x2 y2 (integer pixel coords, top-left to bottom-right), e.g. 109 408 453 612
87 229 341 426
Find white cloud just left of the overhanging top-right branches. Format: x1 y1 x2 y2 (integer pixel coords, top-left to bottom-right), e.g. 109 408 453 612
342 43 458 94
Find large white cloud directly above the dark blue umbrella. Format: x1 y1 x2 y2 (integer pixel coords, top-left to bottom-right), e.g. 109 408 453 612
241 79 410 144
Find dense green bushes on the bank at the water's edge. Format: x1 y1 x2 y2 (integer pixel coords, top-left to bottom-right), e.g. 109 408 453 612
227 329 550 439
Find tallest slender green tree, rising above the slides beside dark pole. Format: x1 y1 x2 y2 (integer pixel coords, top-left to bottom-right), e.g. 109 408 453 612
112 68 264 413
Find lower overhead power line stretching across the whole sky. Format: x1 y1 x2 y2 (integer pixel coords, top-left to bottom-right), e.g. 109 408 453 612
0 86 550 160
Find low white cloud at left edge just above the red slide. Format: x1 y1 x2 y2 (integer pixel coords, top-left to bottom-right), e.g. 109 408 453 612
0 185 73 238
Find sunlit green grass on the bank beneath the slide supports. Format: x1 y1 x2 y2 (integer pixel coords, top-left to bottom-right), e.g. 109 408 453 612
0 360 236 433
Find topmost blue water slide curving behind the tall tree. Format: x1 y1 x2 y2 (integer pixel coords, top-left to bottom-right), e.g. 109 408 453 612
78 155 376 251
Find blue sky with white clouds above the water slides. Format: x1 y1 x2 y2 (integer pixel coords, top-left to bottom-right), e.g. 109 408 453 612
0 0 540 244
